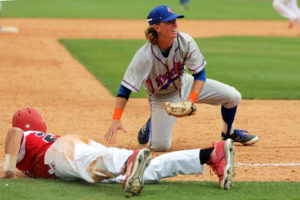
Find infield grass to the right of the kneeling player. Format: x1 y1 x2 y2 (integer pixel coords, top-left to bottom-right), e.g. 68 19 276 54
197 37 300 99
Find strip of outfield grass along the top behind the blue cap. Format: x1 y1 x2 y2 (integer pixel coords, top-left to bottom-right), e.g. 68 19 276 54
3 0 284 20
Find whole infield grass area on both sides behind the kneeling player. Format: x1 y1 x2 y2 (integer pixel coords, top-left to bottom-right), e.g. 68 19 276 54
60 37 300 99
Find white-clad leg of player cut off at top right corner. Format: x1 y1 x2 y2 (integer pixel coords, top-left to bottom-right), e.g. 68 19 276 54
273 0 300 28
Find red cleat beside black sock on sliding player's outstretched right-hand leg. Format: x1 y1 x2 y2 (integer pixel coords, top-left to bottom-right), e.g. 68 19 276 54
207 139 235 190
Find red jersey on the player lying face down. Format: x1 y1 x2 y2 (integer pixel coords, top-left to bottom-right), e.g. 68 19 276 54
16 131 59 178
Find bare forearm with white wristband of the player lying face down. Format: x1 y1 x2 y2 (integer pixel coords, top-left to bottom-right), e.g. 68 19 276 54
4 127 23 178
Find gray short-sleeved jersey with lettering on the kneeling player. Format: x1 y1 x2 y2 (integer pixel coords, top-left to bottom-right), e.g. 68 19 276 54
121 32 206 94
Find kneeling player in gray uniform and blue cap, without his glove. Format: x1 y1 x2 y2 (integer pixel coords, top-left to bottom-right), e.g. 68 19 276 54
105 5 258 151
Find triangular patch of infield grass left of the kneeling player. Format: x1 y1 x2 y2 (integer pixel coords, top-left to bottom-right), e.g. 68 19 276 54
59 39 146 97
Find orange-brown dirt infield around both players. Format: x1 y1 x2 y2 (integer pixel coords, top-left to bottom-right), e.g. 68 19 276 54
0 19 300 181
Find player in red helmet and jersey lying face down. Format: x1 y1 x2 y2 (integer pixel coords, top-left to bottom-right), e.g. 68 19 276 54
4 108 235 191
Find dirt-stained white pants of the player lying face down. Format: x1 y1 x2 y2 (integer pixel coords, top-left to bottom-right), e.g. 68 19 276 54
45 135 204 183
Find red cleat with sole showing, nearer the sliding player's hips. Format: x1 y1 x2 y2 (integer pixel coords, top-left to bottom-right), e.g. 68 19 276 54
123 149 151 197
